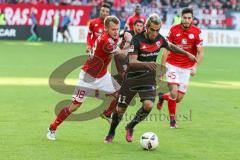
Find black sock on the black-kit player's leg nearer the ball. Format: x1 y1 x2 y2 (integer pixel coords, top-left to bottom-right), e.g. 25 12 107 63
127 107 151 128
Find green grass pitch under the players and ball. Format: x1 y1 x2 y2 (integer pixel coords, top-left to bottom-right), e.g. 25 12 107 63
0 41 240 160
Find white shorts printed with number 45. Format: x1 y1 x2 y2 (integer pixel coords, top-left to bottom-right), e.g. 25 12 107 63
166 63 191 93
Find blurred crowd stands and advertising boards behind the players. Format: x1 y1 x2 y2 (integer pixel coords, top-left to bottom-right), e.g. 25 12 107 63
0 0 240 47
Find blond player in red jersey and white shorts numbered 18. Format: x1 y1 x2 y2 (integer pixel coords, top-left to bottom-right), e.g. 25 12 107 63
47 16 120 140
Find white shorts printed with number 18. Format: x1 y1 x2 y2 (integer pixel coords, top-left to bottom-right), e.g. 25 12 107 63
72 70 120 103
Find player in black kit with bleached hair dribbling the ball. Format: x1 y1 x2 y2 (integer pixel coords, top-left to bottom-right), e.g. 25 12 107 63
104 14 195 143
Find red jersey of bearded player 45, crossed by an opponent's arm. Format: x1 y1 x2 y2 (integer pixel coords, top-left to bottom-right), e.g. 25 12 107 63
167 24 203 68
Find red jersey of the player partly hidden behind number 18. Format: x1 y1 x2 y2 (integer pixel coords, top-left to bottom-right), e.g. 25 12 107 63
87 18 104 47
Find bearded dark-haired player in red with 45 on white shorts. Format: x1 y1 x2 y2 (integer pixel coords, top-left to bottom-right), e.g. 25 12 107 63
157 8 203 128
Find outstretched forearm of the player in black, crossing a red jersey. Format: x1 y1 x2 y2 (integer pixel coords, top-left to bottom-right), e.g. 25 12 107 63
165 42 197 61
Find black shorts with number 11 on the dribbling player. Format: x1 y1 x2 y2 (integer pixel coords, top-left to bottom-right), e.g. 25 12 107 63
118 70 156 108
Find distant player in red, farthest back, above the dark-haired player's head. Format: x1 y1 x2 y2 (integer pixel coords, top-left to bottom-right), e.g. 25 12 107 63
126 5 146 30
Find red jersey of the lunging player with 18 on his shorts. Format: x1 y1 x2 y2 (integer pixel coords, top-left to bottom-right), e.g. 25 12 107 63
82 32 118 78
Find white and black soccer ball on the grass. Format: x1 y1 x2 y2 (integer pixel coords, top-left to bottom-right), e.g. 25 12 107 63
140 132 159 150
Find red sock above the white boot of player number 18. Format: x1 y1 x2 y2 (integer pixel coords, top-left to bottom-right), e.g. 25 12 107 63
50 107 71 130
